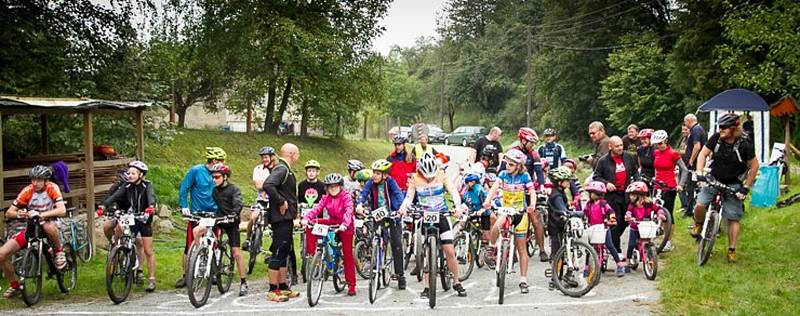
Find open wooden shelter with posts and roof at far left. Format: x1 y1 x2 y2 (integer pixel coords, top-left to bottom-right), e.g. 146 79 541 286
0 96 150 244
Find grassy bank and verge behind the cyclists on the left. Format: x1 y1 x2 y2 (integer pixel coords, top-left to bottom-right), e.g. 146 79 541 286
0 130 392 310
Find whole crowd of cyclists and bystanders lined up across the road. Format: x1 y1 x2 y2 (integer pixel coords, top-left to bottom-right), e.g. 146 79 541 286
0 114 758 308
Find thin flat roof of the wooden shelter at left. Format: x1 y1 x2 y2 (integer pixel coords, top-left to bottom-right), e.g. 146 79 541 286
0 96 151 110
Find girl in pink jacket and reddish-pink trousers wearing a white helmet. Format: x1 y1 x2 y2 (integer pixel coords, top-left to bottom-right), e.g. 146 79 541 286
301 173 356 296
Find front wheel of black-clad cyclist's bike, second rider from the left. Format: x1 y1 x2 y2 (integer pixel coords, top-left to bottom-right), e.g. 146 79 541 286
106 246 133 304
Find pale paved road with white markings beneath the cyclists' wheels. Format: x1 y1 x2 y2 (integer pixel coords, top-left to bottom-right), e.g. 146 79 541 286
11 146 659 315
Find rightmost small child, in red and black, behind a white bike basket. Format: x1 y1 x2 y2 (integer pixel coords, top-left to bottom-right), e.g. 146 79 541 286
625 181 666 273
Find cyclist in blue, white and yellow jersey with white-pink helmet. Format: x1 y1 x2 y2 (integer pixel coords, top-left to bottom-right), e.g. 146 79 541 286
483 149 547 294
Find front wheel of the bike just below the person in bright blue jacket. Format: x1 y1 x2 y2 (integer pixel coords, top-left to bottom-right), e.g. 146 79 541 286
186 247 216 308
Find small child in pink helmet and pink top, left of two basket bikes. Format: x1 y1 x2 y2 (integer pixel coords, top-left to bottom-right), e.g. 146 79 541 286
583 181 626 277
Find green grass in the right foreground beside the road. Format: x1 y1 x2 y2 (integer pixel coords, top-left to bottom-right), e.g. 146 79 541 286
658 179 800 315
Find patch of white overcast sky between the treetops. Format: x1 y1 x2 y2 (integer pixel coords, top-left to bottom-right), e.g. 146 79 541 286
372 0 446 54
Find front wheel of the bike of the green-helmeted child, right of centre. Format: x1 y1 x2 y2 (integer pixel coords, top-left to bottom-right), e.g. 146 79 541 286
551 240 600 297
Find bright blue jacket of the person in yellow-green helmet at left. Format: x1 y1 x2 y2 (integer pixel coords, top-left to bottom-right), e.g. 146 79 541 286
180 164 217 213
